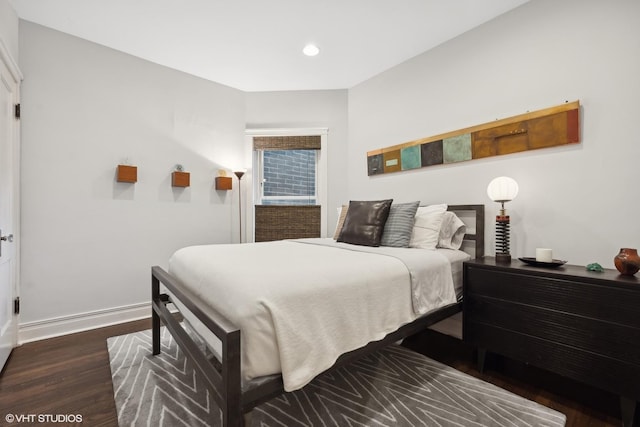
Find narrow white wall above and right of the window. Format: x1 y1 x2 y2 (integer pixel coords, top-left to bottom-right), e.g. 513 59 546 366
246 90 348 235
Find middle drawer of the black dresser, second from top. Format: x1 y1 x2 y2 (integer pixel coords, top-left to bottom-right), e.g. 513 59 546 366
464 294 640 366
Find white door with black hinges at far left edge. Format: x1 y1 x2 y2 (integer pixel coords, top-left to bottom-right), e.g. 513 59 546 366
0 49 19 369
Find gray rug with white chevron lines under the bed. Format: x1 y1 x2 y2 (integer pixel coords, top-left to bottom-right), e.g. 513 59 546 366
107 328 566 427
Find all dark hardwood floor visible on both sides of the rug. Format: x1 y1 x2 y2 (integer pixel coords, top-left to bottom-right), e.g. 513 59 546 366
0 320 637 427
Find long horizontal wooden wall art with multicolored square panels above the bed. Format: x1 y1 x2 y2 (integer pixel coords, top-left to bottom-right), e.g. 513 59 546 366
367 101 580 176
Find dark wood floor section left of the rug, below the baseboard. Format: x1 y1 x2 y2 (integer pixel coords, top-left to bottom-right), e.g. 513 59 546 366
0 320 151 427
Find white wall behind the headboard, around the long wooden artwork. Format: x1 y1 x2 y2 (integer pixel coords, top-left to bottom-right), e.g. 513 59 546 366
348 0 640 267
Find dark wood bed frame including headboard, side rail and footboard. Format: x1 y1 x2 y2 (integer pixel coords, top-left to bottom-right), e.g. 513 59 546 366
151 205 484 427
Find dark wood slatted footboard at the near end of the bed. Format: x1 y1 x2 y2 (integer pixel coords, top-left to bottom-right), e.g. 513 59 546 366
151 266 245 427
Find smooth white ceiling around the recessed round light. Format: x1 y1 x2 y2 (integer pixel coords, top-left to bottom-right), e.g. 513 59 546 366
10 0 529 91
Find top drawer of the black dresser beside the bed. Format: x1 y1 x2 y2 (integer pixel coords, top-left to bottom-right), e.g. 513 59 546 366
465 266 640 329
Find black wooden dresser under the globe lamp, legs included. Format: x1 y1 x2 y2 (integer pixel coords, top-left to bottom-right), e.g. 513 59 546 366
463 257 640 426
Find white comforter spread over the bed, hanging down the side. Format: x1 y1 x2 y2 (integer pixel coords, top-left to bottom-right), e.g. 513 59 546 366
169 239 456 391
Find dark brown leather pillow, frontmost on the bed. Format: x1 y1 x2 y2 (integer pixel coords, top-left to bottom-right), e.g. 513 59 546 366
338 199 393 246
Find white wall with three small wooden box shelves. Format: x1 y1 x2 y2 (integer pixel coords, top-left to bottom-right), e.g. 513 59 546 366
20 21 245 340
